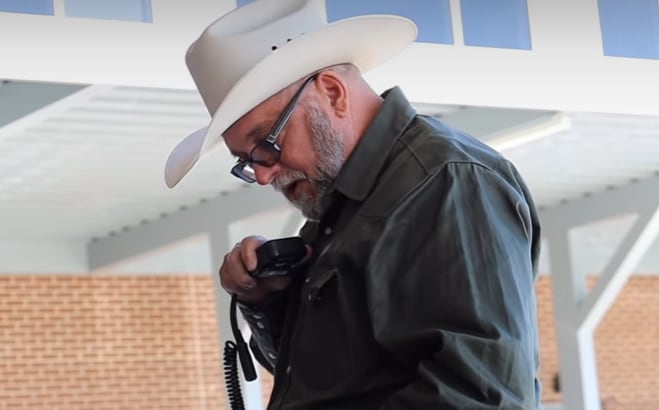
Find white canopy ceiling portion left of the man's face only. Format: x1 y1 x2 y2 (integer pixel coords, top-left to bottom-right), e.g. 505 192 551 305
0 81 241 239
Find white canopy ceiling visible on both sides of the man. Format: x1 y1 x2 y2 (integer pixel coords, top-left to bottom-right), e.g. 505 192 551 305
0 79 659 272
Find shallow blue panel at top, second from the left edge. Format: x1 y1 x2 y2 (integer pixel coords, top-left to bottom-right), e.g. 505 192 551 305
64 0 153 23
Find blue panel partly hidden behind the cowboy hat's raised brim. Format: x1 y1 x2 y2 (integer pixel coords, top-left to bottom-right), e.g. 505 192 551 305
326 0 453 44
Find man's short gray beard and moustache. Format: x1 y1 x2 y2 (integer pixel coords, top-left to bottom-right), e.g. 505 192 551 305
272 100 344 219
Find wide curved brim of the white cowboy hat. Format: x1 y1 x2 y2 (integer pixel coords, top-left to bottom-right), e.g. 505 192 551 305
165 15 417 188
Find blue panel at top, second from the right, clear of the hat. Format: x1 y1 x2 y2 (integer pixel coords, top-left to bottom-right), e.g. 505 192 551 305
460 0 532 50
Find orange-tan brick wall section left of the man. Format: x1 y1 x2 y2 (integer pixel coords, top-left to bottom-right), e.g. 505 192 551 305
0 276 223 410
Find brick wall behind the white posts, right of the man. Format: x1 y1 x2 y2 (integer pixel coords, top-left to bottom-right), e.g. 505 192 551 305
536 276 659 410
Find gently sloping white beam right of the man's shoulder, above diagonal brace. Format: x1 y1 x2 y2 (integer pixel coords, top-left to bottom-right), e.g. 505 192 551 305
540 175 659 228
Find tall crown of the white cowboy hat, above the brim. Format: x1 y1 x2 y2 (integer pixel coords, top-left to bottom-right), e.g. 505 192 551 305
186 0 327 115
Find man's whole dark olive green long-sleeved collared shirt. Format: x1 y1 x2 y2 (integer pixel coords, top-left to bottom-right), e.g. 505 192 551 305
241 88 541 410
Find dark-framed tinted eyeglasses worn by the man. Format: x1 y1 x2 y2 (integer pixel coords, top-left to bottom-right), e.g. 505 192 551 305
231 75 316 184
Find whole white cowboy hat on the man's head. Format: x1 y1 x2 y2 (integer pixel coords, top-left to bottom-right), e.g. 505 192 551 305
165 0 417 188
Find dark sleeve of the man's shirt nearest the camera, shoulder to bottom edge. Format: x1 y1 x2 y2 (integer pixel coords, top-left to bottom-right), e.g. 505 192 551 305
367 163 540 410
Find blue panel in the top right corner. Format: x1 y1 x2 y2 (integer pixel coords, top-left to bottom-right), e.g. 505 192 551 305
598 0 659 59
